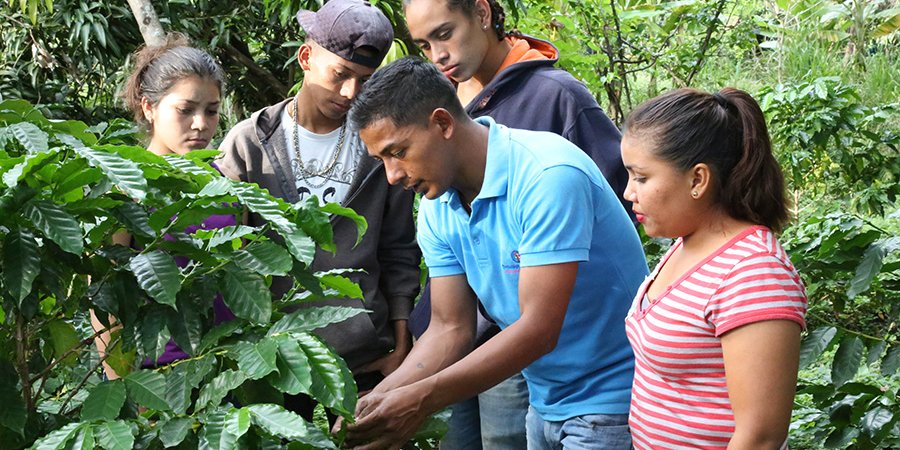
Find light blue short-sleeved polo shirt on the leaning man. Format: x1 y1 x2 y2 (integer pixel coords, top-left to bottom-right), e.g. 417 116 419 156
418 117 648 421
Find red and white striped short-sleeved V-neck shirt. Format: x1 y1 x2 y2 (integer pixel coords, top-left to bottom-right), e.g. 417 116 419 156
625 226 806 449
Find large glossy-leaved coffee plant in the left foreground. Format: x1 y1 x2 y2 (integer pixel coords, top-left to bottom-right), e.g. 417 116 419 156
0 101 365 449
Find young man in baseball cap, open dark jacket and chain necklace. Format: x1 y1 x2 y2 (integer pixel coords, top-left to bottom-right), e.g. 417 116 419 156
218 0 420 415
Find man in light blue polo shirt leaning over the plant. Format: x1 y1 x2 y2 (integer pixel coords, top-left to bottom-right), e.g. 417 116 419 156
347 58 647 449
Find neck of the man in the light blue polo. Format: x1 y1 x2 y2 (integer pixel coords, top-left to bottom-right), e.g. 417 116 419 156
452 120 489 205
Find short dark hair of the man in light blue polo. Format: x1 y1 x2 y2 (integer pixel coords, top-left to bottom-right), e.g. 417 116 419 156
349 56 466 130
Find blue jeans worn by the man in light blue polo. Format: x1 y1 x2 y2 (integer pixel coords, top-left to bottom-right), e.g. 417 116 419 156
526 408 631 450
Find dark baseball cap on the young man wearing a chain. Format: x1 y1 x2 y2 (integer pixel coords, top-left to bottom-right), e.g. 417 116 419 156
297 0 394 69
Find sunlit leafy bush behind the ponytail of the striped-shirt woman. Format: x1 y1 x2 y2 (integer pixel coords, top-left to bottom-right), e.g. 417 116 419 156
759 77 900 215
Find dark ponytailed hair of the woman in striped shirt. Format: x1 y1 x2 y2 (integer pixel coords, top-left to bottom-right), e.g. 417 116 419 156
624 88 789 232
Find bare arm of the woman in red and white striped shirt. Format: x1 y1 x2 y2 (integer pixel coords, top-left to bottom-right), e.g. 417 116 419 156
722 320 800 450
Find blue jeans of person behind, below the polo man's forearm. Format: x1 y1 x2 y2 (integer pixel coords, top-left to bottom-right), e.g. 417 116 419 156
440 373 528 450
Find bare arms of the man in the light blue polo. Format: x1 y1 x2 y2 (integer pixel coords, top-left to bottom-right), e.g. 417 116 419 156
348 262 578 450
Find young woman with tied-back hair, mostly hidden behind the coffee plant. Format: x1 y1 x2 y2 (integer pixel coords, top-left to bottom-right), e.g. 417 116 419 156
92 34 236 379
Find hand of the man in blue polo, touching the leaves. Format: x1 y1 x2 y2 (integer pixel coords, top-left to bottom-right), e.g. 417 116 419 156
344 385 432 450
